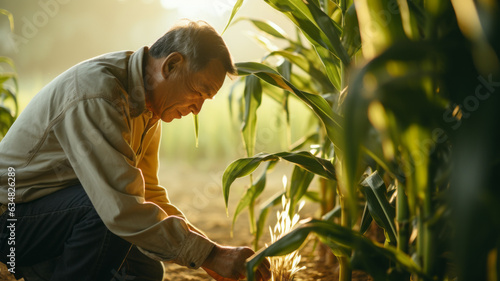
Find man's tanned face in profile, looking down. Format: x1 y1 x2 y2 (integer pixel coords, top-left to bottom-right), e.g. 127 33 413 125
149 56 226 122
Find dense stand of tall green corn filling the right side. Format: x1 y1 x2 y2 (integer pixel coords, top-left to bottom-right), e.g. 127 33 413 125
223 0 500 280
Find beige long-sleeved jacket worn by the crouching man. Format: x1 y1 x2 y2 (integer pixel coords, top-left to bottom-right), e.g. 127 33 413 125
0 47 214 268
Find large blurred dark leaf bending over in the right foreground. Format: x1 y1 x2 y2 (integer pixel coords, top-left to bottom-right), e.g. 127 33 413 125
343 41 442 230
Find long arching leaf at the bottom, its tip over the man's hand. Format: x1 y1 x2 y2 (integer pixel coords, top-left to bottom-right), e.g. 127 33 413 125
247 220 423 281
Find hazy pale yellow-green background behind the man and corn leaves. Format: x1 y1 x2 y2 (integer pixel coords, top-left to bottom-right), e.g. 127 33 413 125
0 0 310 220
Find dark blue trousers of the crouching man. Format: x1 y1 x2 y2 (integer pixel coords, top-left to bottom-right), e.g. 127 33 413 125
0 185 163 281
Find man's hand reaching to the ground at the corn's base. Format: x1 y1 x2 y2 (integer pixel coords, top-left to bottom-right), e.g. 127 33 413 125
201 245 271 281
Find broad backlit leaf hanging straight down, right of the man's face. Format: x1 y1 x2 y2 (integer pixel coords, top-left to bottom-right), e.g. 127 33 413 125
241 76 262 156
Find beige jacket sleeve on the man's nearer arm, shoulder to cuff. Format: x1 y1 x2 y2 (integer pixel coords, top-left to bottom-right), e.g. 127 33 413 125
53 98 214 268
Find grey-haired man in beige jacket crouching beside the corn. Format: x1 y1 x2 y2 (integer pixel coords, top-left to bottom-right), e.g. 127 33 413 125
0 22 270 281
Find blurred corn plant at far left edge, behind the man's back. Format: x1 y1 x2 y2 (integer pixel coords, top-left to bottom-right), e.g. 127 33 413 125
0 9 19 140
